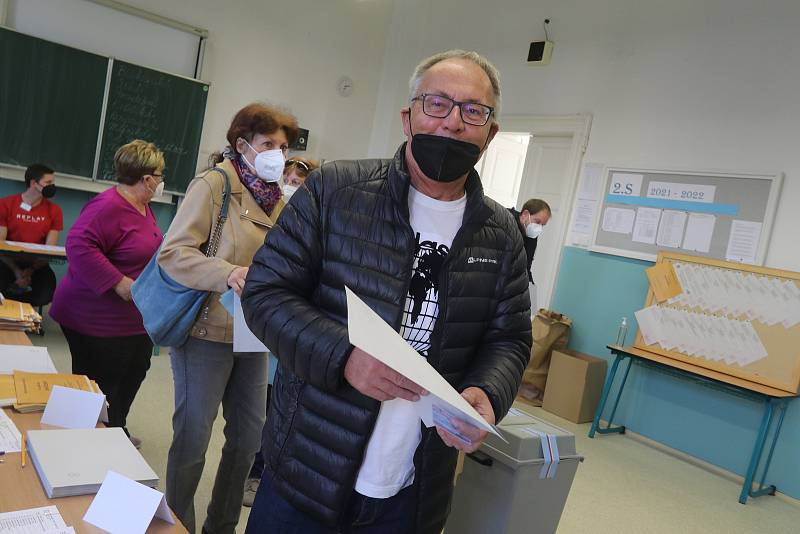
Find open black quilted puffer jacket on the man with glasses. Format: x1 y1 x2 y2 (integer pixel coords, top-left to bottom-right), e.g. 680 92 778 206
242 145 531 533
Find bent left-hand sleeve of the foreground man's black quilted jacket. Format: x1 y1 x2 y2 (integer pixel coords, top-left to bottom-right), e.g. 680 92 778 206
242 171 352 391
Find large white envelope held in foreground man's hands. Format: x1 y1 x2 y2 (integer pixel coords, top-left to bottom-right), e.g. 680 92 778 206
345 287 503 441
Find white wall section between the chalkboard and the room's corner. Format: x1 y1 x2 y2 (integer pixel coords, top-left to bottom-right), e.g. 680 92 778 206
118 0 392 165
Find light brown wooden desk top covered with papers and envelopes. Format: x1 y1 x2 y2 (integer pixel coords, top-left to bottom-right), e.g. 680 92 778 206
0 336 187 534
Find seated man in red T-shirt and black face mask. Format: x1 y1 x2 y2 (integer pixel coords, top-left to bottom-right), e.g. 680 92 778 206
0 163 64 306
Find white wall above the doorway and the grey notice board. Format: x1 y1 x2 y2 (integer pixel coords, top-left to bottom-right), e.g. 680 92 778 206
369 0 800 270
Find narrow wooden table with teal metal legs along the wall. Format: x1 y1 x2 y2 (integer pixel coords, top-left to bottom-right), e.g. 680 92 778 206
589 345 797 504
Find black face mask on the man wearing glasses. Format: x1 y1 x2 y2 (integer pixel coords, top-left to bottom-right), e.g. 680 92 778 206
411 134 481 182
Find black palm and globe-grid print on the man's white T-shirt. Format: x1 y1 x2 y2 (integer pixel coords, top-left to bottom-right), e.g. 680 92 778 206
400 232 450 357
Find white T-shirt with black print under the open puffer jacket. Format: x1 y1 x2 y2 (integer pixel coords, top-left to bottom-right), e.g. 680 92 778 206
355 187 467 499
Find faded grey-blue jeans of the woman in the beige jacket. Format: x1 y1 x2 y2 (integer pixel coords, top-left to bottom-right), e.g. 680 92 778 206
166 337 267 534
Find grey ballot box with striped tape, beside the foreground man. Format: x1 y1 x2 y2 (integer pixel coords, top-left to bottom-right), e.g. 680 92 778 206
444 404 583 534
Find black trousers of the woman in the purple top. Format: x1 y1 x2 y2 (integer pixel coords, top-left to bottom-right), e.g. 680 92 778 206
61 326 153 434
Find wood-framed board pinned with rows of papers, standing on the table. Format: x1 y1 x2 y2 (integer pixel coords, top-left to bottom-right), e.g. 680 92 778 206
634 253 800 394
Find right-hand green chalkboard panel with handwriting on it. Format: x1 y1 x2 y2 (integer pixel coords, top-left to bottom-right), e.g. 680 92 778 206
97 60 208 192
